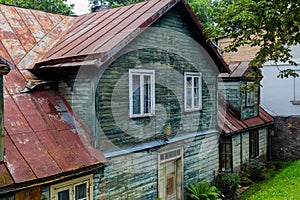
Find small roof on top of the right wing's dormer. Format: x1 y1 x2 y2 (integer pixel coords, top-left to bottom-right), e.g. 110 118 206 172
219 61 251 78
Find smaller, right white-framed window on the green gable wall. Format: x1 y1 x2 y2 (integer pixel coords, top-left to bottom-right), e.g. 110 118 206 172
184 73 202 111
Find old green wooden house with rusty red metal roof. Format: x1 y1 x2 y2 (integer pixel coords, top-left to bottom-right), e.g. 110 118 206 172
0 0 280 200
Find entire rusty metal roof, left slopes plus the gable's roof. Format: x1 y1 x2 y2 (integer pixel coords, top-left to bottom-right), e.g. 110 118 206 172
0 0 229 193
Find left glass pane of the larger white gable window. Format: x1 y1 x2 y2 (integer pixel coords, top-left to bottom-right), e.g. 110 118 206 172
132 75 141 114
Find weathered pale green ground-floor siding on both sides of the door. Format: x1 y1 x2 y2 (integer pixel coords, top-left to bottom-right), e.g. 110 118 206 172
94 132 219 200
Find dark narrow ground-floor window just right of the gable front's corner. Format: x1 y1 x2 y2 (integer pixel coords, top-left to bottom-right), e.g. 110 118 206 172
220 137 232 172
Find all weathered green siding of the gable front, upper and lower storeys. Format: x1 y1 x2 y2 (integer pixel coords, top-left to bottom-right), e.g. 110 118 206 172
56 4 219 200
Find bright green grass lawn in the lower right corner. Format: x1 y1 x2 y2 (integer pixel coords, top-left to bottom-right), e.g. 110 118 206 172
241 160 300 200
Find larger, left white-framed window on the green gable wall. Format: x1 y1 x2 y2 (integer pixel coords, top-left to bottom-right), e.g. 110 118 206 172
129 69 155 117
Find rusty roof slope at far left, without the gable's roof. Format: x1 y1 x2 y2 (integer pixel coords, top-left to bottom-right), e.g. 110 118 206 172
0 4 105 193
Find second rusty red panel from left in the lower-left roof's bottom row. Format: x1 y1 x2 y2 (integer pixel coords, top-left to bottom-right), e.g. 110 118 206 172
11 133 62 178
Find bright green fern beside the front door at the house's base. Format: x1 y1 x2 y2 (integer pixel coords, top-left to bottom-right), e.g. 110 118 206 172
186 180 220 200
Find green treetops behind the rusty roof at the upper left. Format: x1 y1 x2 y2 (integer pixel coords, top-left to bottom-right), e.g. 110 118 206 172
0 0 74 15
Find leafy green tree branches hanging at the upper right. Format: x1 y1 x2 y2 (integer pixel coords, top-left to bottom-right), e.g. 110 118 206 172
212 0 300 78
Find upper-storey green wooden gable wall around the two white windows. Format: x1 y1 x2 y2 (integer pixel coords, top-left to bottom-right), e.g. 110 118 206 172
60 5 217 151
